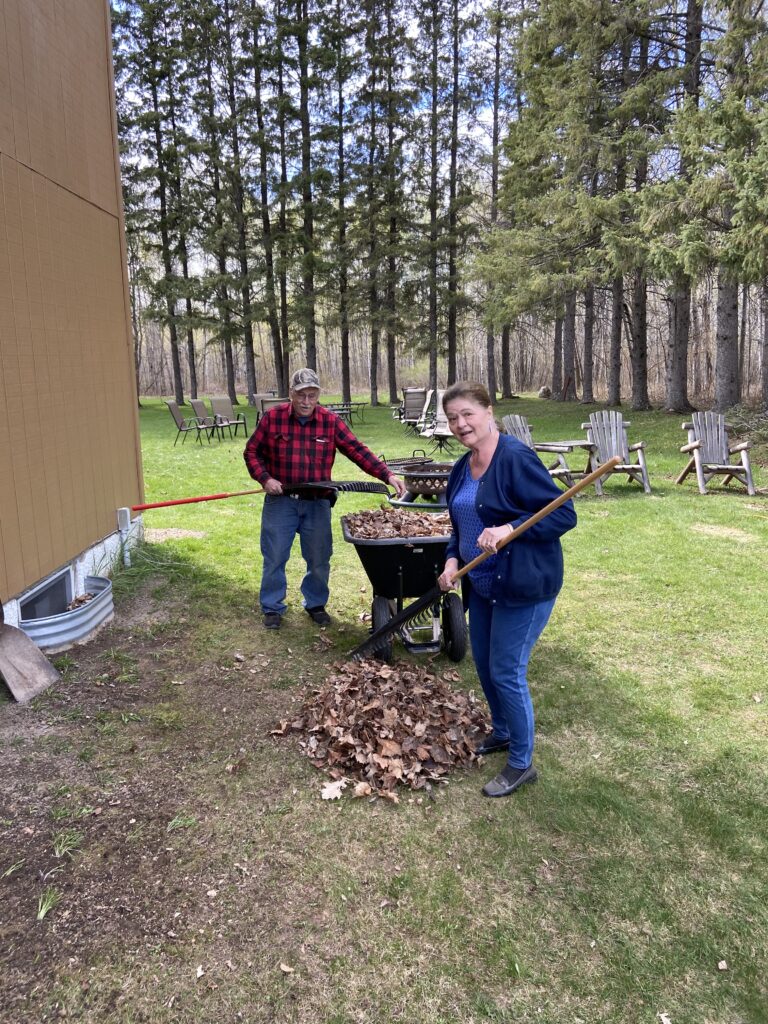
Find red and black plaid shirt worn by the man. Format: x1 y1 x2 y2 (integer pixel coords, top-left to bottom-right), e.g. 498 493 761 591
244 401 391 484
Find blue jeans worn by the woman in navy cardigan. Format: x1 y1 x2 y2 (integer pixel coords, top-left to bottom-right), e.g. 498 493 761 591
469 590 555 768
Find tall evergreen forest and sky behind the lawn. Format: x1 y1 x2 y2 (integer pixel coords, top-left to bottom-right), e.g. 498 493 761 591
113 0 768 412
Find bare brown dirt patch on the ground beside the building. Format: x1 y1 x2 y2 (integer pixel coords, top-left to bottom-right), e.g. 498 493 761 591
0 586 303 1024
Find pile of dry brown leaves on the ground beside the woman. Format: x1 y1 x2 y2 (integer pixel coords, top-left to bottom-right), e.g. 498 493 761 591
271 660 488 803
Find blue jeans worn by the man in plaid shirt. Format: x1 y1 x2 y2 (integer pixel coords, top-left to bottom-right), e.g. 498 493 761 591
259 495 333 615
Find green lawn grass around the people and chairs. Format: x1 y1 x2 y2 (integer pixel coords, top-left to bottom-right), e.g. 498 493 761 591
7 397 768 1024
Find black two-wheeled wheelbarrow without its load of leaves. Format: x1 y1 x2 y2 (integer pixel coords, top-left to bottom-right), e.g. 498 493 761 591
341 516 467 662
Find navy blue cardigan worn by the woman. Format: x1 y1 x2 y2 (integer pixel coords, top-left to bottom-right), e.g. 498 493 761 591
445 434 577 605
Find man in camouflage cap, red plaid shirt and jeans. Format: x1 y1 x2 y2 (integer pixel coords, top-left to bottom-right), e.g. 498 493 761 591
244 368 406 630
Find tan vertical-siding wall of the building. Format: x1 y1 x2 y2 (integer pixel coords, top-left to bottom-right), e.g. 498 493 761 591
0 0 142 599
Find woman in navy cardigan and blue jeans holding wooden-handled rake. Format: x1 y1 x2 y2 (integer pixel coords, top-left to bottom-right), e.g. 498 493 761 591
438 381 575 797
